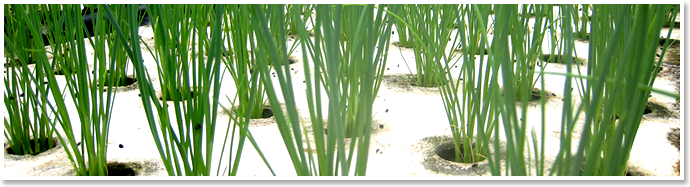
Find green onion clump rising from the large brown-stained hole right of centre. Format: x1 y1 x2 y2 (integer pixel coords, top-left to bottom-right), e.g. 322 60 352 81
436 5 498 163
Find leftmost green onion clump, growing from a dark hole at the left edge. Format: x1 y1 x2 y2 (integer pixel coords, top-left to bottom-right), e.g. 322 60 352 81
4 5 55 155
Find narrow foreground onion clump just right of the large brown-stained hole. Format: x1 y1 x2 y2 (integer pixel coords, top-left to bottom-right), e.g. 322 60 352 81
489 5 548 175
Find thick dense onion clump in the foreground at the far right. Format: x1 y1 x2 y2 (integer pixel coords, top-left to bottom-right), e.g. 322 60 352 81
552 4 678 176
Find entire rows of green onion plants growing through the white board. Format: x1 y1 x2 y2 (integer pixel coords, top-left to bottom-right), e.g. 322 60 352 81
4 4 680 176
